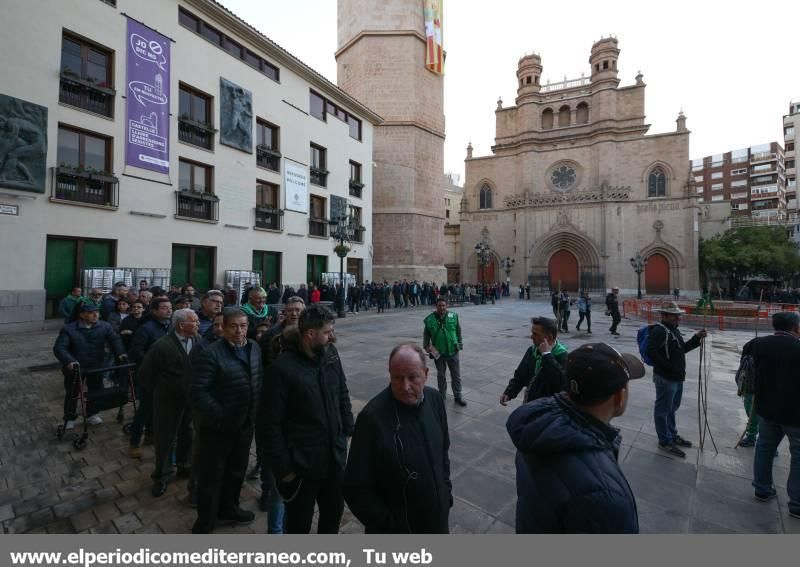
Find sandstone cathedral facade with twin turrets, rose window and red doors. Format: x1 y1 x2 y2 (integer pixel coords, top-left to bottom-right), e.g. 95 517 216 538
460 37 700 295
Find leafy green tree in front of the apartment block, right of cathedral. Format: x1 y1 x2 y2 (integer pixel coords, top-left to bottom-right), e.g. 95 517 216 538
700 226 800 280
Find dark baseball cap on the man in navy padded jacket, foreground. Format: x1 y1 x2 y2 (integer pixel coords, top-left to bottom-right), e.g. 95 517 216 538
567 343 644 402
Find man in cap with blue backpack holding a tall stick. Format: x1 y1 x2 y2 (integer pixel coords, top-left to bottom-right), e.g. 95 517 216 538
647 301 706 458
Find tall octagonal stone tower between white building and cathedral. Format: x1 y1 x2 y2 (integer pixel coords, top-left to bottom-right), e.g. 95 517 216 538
336 0 446 282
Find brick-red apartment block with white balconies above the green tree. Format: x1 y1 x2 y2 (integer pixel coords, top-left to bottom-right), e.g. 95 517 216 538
691 142 797 224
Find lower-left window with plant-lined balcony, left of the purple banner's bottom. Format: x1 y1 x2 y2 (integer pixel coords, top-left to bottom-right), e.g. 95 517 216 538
51 126 117 207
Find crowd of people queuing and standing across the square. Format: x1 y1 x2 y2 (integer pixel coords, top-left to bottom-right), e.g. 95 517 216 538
54 282 800 534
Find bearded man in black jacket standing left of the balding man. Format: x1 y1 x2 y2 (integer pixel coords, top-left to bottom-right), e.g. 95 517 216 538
268 304 353 534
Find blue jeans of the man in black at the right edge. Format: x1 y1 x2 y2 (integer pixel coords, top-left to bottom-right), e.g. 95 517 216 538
753 416 800 514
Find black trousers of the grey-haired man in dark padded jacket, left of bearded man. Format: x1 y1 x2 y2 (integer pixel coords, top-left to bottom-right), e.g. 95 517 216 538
192 421 253 533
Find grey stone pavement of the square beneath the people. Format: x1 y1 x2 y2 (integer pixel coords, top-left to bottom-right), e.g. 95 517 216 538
0 299 800 533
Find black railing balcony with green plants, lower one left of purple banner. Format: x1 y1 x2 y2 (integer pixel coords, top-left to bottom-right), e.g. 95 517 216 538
50 166 119 209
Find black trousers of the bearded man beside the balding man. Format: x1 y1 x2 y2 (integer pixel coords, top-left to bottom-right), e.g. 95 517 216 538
278 464 344 534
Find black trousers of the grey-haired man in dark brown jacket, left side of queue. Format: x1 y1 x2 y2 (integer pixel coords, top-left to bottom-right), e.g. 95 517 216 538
150 384 192 482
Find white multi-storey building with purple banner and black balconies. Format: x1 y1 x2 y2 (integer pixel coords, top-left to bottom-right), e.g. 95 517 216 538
0 0 381 332
